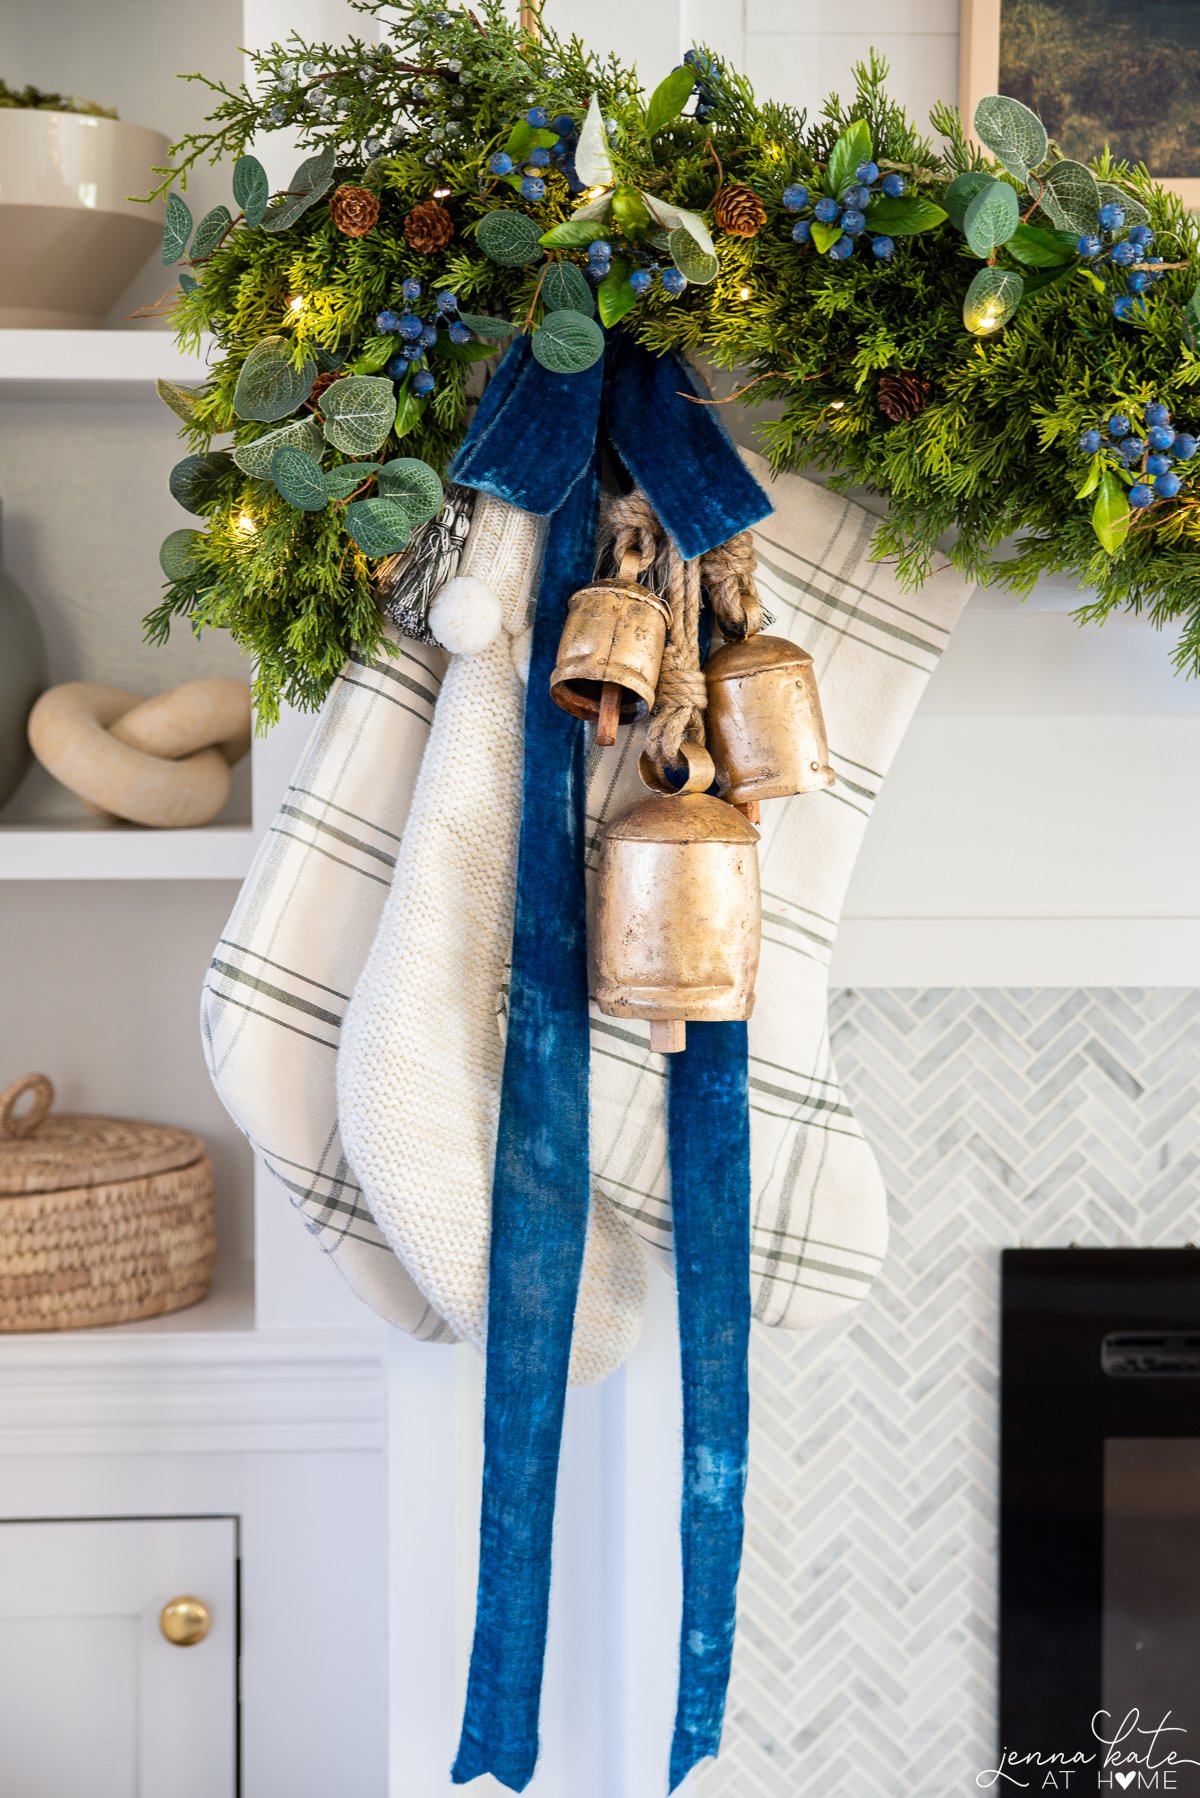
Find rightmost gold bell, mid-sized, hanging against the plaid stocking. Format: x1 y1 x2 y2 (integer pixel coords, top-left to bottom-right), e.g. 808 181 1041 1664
703 636 835 818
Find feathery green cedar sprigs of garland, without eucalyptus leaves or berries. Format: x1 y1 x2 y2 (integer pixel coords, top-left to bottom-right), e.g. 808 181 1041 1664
148 0 1200 723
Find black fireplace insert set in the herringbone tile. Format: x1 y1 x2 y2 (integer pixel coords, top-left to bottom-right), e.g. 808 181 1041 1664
999 1250 1200 1794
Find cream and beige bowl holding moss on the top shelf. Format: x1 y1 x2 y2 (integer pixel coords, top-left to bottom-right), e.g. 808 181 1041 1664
0 108 167 329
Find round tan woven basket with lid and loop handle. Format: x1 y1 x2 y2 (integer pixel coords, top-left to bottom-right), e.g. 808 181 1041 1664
0 1073 216 1331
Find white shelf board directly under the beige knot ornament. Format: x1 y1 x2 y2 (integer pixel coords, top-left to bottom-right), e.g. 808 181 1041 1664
0 823 255 881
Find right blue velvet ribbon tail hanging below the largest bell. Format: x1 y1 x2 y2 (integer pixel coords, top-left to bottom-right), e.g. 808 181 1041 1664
667 1023 750 1791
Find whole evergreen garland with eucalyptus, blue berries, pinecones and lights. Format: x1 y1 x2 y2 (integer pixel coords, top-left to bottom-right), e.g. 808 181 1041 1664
148 0 1200 723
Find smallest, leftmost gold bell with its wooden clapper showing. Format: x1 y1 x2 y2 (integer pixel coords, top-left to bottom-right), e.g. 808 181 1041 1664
551 554 671 744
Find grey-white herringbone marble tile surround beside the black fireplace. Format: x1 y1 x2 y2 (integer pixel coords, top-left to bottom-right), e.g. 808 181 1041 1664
696 987 1200 1798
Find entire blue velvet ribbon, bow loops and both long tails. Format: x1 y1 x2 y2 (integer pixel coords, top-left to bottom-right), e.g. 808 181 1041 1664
450 336 770 1791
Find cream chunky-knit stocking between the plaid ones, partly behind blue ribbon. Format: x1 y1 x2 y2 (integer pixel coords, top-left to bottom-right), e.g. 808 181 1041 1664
338 496 646 1381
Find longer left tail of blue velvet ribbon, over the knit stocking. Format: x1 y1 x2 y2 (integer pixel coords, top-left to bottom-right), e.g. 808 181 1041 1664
452 460 599 1791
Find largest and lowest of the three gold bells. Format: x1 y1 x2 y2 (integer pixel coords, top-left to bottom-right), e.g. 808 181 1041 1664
592 743 761 1054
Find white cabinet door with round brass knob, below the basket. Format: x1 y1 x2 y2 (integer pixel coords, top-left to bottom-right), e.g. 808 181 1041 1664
0 1518 237 1798
